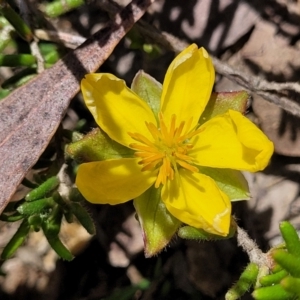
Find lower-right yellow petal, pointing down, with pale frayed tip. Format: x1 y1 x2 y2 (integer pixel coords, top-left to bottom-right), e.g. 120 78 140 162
162 169 231 236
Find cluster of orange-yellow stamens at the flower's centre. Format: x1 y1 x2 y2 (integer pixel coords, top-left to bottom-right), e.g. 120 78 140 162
128 113 202 188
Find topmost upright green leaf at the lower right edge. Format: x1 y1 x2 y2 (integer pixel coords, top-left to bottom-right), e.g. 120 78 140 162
279 221 300 258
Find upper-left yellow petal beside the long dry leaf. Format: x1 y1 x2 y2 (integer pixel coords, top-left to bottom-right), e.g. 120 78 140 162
81 73 156 147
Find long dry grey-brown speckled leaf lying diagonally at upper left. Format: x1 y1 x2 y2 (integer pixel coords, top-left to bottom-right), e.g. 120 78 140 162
0 0 154 213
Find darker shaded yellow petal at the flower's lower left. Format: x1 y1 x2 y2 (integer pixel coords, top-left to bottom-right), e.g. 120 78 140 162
76 158 156 205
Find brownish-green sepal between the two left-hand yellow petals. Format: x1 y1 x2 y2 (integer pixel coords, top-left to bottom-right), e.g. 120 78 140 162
65 128 134 163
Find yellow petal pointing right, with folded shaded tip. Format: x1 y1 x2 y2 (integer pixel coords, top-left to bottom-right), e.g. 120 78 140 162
191 110 274 172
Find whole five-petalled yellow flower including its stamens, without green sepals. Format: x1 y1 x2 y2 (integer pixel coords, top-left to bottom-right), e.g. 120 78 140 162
76 44 273 236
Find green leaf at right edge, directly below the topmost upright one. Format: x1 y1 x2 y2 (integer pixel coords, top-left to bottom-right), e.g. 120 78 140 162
271 249 300 278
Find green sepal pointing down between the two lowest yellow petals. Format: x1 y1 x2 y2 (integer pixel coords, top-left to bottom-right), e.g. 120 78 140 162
133 186 181 257
